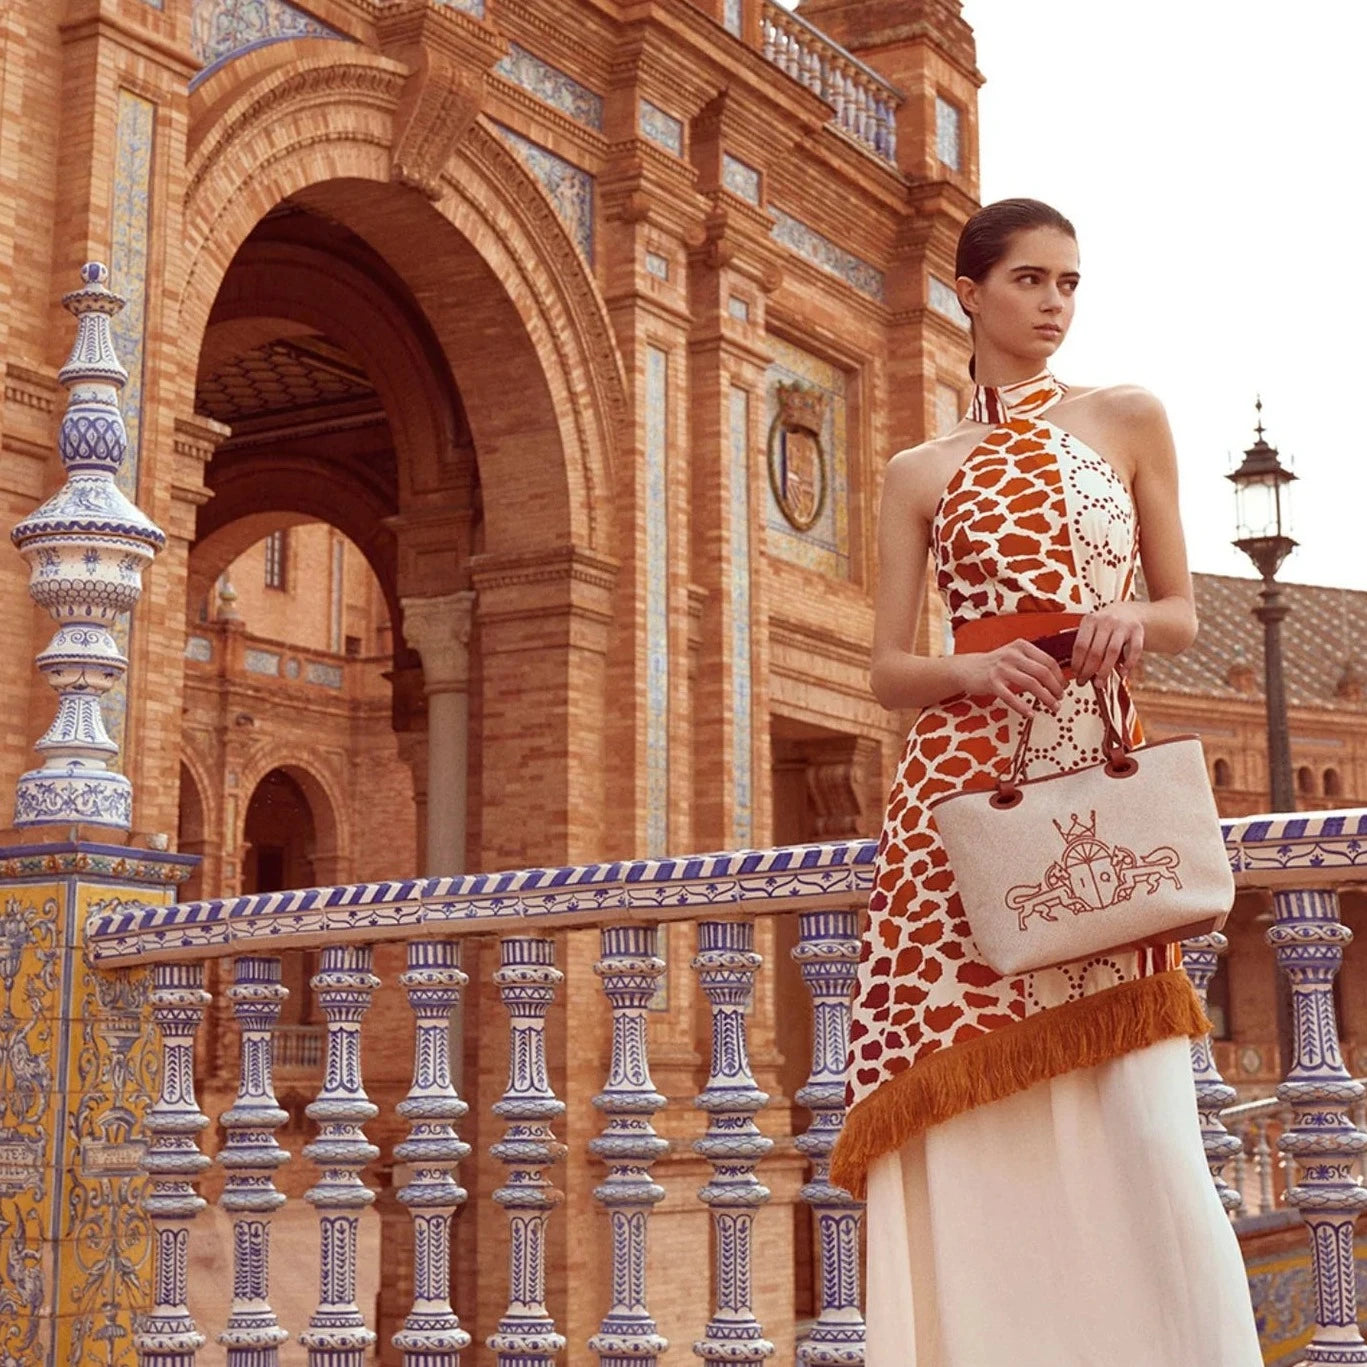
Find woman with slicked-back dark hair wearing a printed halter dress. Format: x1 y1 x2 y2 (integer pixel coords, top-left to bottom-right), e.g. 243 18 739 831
833 200 1262 1367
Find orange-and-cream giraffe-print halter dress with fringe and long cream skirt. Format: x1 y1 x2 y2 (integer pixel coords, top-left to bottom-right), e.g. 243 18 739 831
831 372 1262 1367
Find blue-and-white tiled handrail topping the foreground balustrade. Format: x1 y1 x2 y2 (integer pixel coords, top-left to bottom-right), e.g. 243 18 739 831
85 811 1367 964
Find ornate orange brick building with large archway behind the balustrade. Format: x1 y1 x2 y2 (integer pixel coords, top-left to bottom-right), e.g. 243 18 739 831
0 0 1345 1363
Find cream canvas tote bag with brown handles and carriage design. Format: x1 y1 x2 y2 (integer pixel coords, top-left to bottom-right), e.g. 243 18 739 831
931 633 1234 976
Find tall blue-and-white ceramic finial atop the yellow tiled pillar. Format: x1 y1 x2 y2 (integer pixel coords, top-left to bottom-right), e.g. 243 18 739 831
10 261 165 830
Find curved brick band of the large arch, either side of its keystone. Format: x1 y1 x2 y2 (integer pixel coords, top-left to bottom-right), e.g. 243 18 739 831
176 42 626 552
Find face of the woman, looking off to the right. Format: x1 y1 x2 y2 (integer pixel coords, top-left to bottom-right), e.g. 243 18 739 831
957 228 1079 362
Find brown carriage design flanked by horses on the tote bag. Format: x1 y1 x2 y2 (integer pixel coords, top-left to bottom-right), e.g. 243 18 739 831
1006 812 1182 931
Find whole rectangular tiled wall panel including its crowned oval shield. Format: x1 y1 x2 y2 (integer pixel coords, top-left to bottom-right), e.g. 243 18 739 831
761 344 849 578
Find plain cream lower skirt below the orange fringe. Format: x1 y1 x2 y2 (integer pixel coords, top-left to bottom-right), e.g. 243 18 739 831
865 1039 1263 1367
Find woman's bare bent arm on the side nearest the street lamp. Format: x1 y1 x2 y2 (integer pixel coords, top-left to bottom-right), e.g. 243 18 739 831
1073 387 1196 684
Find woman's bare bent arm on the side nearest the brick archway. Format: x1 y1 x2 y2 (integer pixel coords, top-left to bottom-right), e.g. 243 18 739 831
869 451 1064 715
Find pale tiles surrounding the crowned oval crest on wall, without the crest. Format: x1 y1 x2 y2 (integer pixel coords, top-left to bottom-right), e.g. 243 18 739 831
755 336 850 578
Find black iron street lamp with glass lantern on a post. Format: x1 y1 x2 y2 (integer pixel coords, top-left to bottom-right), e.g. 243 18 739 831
1228 399 1296 812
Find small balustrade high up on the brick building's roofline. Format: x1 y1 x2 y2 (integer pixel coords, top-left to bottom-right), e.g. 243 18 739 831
760 0 905 165
